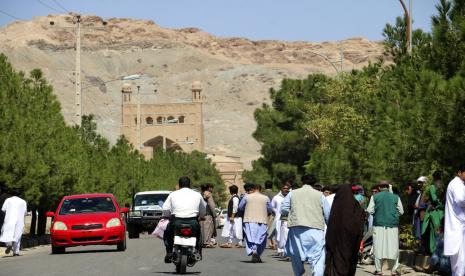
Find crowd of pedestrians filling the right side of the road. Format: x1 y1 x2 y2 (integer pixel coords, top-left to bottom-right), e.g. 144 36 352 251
186 164 465 276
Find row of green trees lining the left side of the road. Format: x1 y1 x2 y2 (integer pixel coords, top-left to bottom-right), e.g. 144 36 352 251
0 54 224 235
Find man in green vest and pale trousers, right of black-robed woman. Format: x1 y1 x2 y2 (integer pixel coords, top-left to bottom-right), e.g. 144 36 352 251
367 181 404 275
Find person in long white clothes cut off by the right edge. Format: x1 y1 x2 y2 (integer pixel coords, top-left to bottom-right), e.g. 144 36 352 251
444 164 465 276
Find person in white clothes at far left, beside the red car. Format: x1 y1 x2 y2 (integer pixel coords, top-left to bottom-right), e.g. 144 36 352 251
0 190 27 256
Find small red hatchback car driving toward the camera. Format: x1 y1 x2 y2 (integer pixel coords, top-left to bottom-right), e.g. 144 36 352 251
47 194 129 254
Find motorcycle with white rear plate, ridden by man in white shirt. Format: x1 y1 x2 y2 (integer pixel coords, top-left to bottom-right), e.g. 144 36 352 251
171 224 202 274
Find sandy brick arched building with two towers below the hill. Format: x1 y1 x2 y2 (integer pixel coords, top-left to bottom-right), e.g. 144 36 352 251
121 81 244 191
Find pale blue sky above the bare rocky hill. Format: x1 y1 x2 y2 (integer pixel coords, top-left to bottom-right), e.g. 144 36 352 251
0 0 439 41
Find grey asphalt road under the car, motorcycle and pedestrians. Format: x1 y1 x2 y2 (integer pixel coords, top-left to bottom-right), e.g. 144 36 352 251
0 236 372 276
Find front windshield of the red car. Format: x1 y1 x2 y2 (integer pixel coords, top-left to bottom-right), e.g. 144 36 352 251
60 197 116 215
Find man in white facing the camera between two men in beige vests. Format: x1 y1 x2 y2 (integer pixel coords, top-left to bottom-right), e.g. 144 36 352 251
271 182 291 257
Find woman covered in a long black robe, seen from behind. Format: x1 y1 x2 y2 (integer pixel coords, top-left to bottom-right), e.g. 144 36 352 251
325 185 365 276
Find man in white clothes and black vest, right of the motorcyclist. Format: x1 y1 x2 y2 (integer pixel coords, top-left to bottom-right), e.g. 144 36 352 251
220 185 243 248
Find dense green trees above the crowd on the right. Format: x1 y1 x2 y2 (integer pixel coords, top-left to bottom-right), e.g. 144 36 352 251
244 0 465 190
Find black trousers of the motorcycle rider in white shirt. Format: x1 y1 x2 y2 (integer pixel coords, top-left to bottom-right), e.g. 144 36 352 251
163 217 203 254
